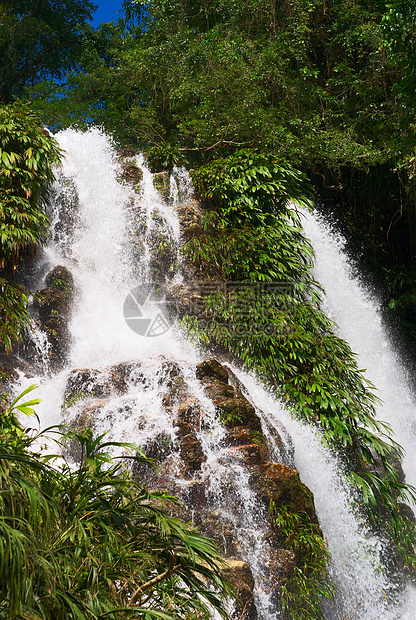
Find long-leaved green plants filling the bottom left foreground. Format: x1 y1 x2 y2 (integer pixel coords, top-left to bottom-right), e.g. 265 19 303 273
0 386 230 620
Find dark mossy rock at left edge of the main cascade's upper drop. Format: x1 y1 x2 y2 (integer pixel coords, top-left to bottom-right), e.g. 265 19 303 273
34 265 74 370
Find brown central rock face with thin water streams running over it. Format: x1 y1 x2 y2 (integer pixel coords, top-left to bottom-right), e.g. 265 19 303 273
64 359 319 620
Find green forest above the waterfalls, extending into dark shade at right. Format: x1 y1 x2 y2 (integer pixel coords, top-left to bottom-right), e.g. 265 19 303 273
25 0 416 348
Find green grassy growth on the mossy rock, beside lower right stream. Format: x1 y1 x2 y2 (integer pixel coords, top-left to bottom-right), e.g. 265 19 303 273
270 502 335 620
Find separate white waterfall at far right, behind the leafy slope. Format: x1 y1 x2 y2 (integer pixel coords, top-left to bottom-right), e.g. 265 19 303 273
302 212 416 620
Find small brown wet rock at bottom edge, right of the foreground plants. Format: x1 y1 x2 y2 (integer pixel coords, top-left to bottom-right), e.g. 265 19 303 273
225 560 257 620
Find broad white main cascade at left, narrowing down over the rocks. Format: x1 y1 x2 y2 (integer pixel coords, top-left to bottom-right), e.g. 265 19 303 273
17 130 279 620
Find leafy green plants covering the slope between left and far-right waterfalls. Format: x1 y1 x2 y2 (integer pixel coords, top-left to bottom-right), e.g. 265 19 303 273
185 151 416 566
